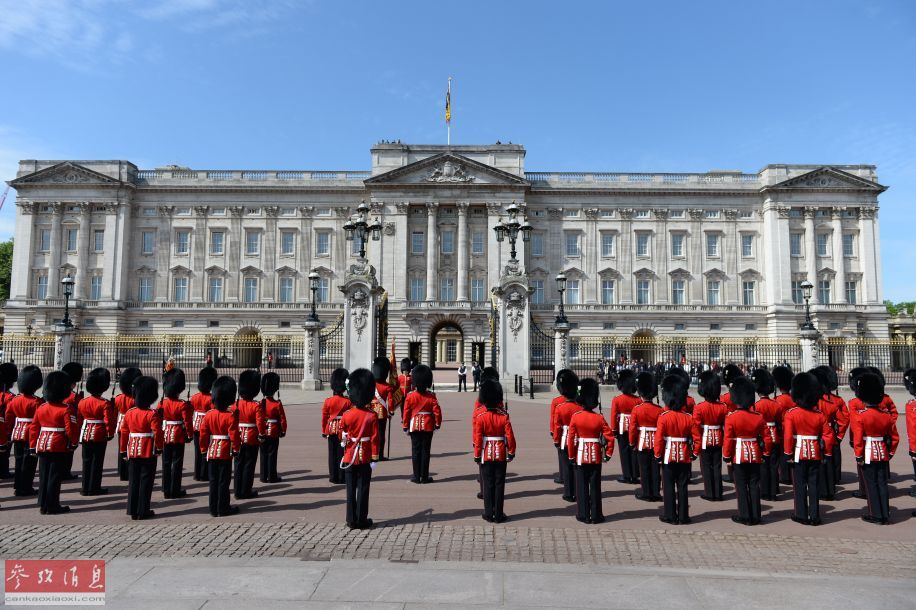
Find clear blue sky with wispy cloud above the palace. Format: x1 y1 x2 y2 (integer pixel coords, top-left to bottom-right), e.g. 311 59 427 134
0 0 916 301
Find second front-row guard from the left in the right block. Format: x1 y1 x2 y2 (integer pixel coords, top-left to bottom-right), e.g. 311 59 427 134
656 374 697 525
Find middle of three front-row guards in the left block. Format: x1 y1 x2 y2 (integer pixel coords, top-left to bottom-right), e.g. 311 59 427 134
119 377 163 521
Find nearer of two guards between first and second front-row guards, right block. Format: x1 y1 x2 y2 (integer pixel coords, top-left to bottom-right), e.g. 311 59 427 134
630 372 660 502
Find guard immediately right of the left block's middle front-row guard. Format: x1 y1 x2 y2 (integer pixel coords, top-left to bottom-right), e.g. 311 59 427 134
159 367 194 499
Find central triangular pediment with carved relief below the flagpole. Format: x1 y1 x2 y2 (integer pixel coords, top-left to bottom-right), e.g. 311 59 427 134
365 153 528 187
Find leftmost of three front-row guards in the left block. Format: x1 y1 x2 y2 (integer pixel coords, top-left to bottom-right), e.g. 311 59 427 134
29 371 79 515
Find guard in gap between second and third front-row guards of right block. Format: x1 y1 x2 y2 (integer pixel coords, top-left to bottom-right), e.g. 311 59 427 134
693 370 728 502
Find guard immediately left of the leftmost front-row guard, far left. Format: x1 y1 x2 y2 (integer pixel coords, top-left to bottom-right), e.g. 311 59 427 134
6 364 42 496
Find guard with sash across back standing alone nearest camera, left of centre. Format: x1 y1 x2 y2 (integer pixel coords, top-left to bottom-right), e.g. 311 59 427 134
340 367 378 529
